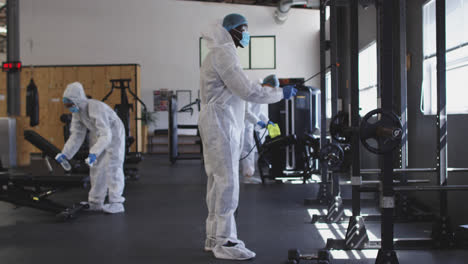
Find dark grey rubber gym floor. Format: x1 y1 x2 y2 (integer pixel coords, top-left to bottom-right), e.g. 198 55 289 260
0 156 468 264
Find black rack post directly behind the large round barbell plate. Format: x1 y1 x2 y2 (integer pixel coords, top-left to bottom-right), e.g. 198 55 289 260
375 0 398 264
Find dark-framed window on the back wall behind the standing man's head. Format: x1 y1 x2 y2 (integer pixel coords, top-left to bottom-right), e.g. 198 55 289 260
200 36 276 70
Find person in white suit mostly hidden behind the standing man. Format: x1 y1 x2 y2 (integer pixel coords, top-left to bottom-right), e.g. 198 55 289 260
240 74 279 184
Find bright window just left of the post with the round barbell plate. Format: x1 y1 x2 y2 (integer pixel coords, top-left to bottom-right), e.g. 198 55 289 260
359 42 377 116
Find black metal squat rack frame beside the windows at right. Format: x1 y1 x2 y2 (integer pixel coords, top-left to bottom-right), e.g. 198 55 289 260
290 0 468 263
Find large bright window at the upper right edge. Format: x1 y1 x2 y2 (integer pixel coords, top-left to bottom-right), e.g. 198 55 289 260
421 0 468 115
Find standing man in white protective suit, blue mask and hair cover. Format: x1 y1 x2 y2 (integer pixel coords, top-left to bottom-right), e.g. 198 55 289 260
198 14 295 260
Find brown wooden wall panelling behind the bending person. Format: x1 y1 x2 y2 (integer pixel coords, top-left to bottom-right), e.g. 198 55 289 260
0 65 141 162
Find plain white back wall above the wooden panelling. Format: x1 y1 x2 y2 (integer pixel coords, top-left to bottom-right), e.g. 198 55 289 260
20 0 319 132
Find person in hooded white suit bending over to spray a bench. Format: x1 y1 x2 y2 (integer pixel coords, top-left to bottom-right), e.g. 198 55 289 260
56 82 125 213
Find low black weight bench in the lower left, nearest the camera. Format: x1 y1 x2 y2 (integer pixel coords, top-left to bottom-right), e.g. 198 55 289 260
0 172 89 221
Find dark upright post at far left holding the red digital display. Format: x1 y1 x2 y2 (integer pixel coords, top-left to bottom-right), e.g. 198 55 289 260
7 0 21 116
